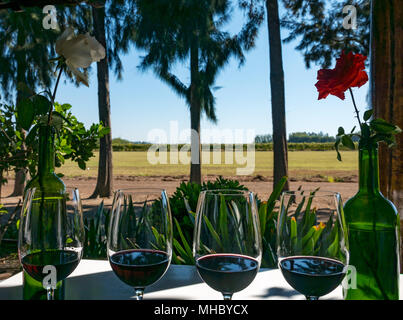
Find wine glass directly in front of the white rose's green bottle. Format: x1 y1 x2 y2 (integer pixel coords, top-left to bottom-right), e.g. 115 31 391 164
18 188 84 300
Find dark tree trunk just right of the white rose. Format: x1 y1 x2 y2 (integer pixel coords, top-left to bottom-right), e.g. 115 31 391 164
90 7 113 198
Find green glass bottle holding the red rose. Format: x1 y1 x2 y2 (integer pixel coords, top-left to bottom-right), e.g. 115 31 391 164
343 143 400 300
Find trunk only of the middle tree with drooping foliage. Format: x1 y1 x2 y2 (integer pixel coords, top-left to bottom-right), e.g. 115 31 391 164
190 43 201 184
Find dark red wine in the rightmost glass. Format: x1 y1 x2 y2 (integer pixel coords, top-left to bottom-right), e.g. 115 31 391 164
280 256 345 297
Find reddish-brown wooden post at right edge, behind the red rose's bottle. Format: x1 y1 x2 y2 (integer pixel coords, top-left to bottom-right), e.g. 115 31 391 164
370 0 403 271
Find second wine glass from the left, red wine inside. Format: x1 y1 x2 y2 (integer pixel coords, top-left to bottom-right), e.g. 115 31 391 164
108 188 172 300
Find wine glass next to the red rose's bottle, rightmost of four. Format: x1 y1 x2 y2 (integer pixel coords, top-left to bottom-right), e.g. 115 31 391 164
277 189 349 300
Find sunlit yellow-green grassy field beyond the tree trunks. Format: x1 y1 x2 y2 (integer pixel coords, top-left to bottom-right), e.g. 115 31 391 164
57 151 358 181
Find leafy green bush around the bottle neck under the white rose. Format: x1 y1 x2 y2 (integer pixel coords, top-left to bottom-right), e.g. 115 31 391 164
4 96 110 176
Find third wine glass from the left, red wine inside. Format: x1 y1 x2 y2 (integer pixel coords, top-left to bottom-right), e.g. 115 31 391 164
193 190 262 300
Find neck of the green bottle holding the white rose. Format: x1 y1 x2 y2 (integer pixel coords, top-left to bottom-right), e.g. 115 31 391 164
38 126 55 176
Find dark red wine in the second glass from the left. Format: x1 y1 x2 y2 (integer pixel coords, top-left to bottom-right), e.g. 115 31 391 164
109 249 170 289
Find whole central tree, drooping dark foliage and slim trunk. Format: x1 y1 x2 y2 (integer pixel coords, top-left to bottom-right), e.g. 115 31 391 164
133 0 261 184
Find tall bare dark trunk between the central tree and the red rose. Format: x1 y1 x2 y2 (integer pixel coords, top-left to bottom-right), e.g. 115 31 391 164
266 0 289 190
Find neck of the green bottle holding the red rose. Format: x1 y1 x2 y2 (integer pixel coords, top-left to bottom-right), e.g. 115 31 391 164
359 146 379 193
